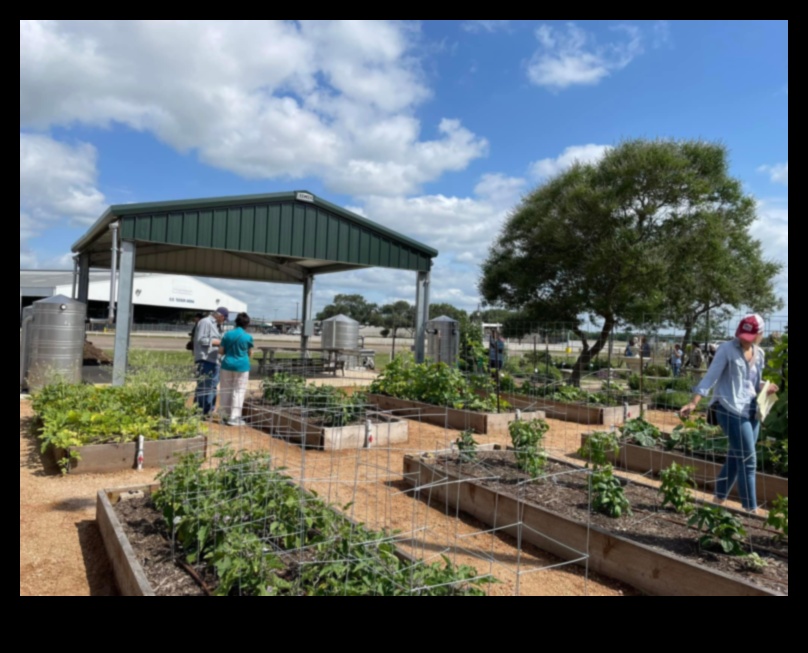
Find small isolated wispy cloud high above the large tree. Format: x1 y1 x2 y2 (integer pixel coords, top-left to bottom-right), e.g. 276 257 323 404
527 23 643 91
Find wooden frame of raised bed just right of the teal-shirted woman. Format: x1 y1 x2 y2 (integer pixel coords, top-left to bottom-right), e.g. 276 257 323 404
238 400 409 451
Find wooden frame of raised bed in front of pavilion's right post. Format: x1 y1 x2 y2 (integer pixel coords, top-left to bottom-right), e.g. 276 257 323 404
367 394 545 435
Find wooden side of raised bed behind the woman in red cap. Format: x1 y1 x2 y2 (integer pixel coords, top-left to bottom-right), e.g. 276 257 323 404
581 433 788 505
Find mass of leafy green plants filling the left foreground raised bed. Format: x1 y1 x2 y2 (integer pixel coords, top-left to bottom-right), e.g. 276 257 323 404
153 449 494 596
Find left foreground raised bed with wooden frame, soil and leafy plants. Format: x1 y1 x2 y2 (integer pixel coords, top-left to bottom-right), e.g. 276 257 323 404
97 453 491 596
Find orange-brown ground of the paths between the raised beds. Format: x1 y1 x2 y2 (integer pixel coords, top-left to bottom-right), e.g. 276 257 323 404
20 400 752 596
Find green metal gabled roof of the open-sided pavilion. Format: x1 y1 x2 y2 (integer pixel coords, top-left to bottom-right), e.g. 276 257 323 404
73 191 438 283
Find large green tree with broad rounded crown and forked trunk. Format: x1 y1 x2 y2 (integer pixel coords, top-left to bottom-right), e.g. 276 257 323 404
480 140 784 383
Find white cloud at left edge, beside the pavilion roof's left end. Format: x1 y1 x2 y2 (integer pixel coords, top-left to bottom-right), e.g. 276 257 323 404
20 133 106 267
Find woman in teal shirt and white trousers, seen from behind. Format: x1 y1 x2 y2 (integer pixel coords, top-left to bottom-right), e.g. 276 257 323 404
219 313 255 426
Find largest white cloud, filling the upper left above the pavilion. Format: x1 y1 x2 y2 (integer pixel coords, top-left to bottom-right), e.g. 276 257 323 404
20 20 487 195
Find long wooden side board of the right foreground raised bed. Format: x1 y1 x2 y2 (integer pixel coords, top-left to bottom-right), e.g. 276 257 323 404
404 452 779 596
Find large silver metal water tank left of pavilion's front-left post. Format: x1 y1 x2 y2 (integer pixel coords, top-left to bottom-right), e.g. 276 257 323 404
27 295 87 391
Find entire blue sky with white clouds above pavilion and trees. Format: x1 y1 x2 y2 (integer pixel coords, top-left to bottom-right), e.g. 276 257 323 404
20 20 788 326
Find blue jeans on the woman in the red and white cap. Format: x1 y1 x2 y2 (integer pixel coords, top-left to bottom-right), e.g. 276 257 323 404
715 402 760 510
